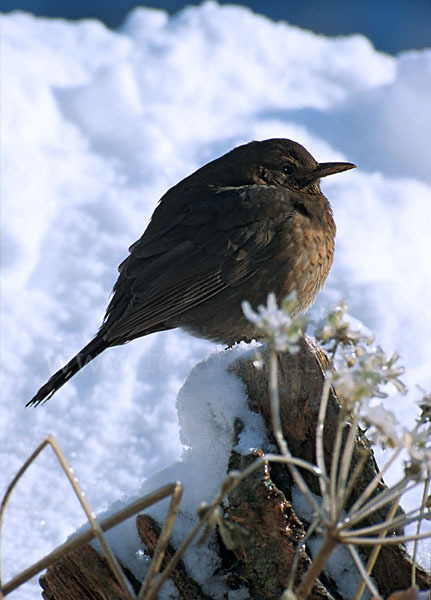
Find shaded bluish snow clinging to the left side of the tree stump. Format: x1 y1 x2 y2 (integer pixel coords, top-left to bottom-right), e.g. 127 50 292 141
87 343 271 599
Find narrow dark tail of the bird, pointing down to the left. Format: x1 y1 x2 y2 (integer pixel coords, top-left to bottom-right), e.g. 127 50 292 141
26 335 109 406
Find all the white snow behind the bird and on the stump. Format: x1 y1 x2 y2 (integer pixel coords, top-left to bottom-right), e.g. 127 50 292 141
0 2 431 600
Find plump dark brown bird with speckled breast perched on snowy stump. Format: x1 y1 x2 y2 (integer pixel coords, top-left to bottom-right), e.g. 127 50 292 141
26 138 356 406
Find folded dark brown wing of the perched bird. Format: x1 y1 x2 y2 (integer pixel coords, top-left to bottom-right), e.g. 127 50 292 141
102 186 292 343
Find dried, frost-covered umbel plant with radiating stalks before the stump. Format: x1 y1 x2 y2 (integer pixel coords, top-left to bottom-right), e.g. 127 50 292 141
244 297 431 600
